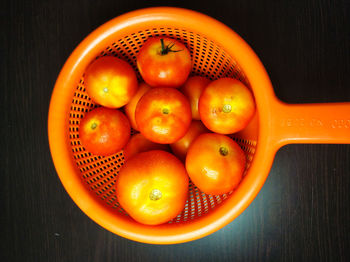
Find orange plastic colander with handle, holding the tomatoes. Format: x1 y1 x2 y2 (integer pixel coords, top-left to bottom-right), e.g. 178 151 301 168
48 7 350 244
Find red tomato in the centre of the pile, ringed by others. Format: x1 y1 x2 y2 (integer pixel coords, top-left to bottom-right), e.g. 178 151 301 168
135 87 192 144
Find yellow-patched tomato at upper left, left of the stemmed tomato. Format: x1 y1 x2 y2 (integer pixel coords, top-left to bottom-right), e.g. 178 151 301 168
84 56 137 108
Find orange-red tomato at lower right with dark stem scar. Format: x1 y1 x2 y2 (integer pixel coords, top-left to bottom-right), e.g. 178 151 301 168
186 133 246 195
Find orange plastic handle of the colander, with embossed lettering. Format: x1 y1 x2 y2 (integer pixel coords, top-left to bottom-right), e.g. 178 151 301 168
269 99 350 147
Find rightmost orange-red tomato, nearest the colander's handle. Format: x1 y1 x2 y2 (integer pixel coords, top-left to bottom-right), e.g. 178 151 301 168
199 78 255 134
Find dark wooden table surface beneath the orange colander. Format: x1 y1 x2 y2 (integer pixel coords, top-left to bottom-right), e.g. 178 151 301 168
0 0 350 262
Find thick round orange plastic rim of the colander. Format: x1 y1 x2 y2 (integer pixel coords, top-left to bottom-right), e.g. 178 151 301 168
48 7 275 244
